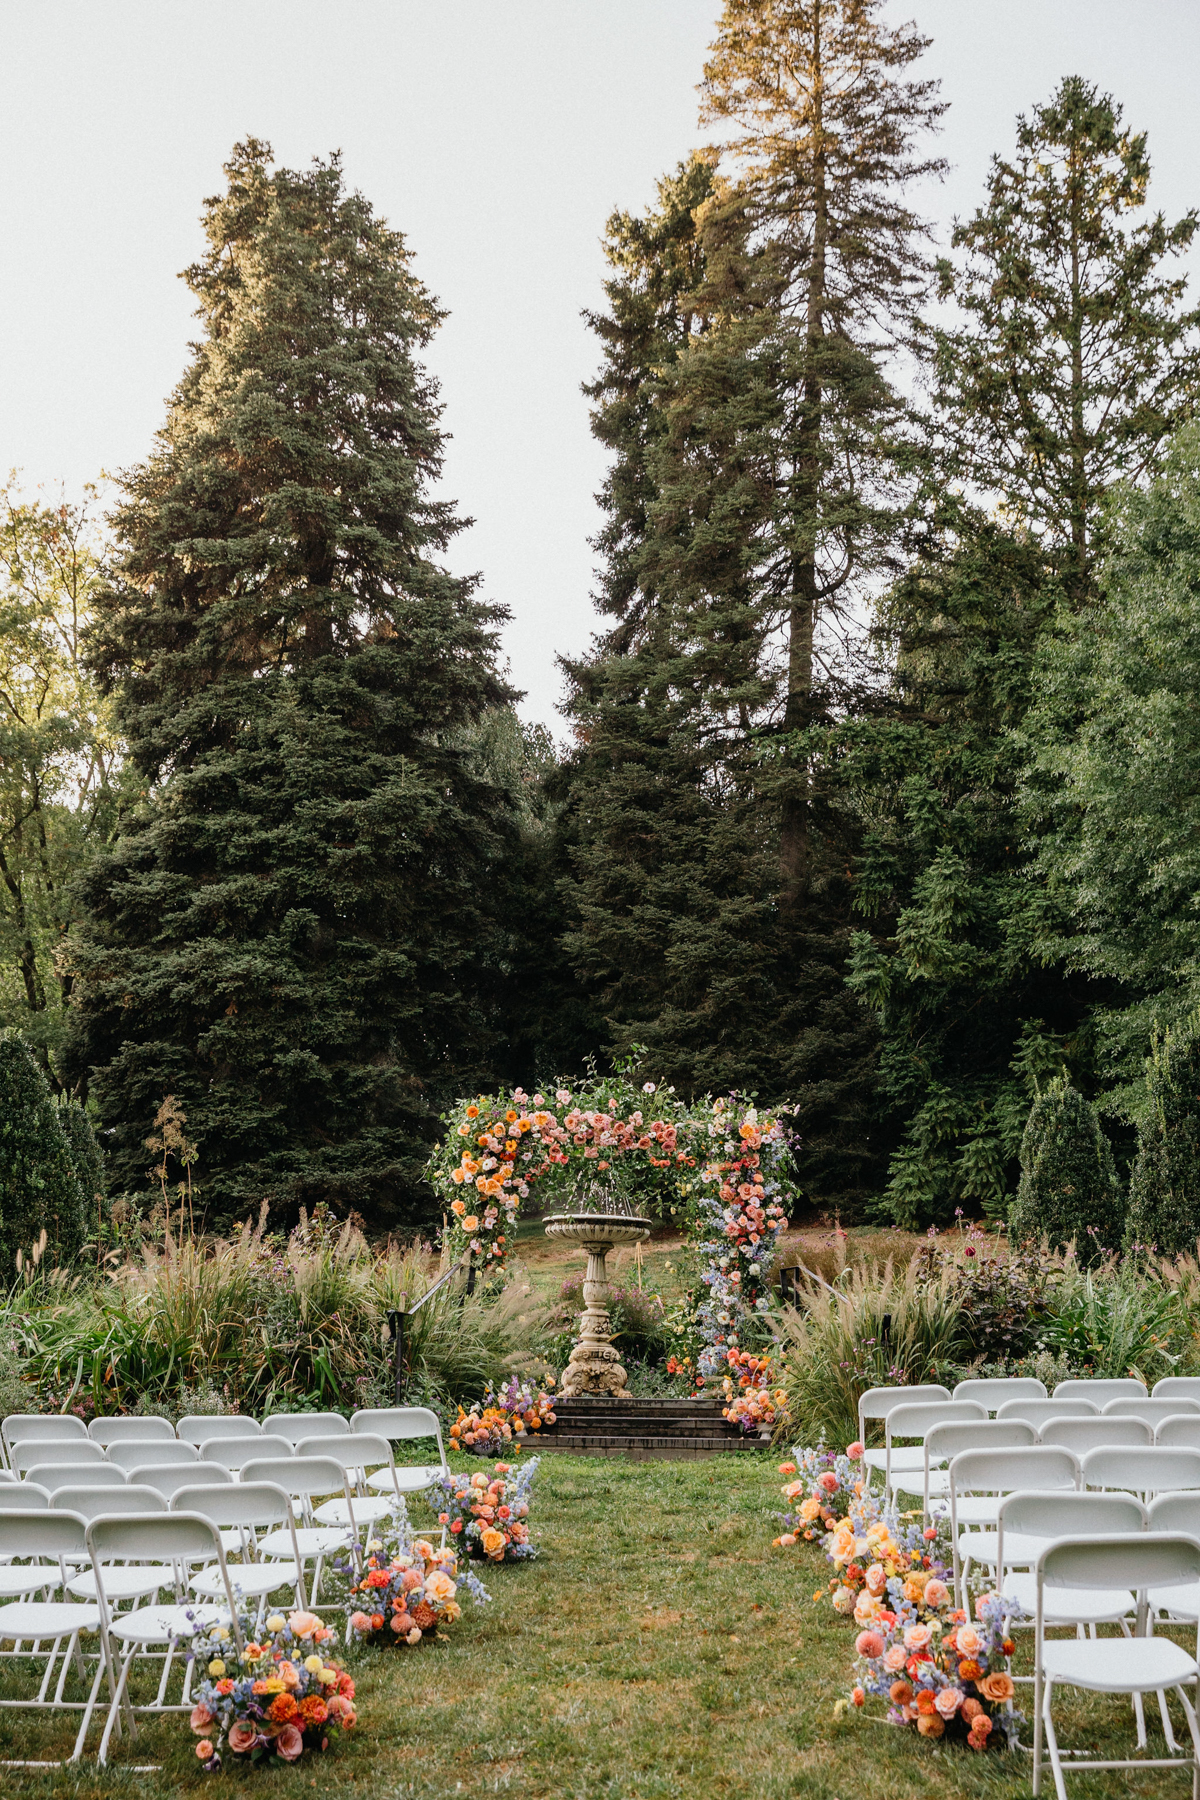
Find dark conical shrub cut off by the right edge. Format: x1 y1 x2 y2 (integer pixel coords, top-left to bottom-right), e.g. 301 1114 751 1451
1128 1013 1200 1256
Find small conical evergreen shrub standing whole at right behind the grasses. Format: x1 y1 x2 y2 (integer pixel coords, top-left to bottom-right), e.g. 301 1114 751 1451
1009 1076 1124 1262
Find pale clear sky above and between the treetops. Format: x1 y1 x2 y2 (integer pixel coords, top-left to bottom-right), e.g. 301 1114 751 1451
0 0 1200 738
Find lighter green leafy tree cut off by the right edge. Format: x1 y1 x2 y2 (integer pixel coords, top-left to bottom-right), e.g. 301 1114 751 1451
1024 427 1200 1116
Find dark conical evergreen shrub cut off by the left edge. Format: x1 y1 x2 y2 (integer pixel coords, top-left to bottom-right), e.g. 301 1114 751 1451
0 1031 86 1285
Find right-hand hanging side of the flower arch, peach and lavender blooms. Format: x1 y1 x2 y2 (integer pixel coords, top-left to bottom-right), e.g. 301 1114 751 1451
696 1100 790 1375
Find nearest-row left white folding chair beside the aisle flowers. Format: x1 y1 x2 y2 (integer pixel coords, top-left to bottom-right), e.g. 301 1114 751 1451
86 1512 243 1764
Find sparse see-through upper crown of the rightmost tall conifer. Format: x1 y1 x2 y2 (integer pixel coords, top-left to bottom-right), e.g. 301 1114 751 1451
936 76 1200 605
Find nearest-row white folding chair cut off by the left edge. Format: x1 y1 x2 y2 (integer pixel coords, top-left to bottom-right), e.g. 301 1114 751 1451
0 1507 104 1762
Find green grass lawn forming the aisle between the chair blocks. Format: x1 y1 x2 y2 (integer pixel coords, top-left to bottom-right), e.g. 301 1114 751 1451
0 1454 1189 1800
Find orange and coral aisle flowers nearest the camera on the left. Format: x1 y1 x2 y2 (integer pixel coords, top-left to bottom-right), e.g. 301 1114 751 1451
189 1613 358 1773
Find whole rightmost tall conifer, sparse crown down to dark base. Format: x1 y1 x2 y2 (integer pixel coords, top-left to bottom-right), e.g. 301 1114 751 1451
847 77 1198 1222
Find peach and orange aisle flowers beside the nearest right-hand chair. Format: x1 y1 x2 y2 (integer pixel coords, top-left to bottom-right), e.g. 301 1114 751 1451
851 1577 1022 1750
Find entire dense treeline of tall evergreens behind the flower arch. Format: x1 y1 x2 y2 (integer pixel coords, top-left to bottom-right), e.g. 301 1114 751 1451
0 0 1200 1238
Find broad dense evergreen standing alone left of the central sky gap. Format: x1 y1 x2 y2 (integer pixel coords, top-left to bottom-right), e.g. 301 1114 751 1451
70 140 507 1224
